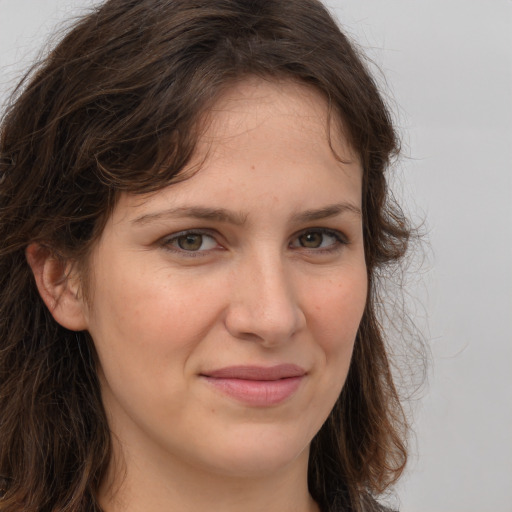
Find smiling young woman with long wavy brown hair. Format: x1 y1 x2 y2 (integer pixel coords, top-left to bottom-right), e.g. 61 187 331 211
0 0 409 512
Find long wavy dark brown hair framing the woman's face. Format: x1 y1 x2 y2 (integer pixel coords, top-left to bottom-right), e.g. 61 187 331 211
0 0 410 512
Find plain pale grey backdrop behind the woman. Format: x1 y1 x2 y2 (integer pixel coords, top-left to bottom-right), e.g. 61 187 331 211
0 0 512 512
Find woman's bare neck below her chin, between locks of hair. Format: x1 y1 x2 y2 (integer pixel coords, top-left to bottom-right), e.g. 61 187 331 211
100 440 319 512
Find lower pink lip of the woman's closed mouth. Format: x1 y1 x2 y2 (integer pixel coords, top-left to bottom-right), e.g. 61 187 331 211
204 376 303 407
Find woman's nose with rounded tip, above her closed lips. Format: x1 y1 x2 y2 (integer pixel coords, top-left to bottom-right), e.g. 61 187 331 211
225 250 306 347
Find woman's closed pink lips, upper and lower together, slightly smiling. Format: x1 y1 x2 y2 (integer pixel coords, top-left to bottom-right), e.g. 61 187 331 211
202 364 306 407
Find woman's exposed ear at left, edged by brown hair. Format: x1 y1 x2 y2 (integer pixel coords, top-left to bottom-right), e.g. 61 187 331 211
25 243 87 331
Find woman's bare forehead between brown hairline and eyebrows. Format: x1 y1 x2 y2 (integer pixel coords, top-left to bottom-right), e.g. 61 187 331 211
114 78 362 220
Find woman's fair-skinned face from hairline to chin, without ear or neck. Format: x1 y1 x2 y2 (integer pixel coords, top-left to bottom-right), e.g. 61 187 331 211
84 79 367 476
